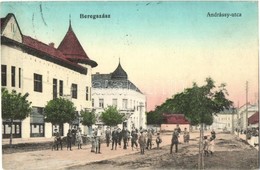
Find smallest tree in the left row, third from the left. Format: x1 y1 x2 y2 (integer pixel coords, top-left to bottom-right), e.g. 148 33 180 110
80 110 97 133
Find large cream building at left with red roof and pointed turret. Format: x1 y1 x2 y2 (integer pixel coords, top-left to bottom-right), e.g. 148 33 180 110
1 14 97 138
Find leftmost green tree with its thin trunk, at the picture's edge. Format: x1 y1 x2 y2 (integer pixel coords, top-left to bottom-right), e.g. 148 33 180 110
2 88 32 147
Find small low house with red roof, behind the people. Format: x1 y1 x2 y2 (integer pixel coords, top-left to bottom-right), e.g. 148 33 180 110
161 114 190 131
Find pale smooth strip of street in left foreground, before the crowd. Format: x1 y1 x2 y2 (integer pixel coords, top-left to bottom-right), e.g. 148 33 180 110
2 135 179 170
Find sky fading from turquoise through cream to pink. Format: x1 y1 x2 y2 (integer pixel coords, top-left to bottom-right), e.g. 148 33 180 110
1 1 259 111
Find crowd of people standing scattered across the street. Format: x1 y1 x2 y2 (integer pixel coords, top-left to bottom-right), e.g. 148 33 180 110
54 125 216 155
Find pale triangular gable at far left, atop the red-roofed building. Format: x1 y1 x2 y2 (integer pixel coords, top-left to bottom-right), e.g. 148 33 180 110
1 14 23 43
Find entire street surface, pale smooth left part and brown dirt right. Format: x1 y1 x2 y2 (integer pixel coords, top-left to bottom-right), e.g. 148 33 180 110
2 132 258 170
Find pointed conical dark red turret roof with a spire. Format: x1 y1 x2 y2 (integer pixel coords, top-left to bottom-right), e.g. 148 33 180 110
58 25 89 60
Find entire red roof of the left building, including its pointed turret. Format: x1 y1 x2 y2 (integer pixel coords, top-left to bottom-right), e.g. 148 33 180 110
1 13 97 72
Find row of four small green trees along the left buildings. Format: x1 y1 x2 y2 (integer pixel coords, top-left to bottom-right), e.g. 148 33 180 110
2 88 125 147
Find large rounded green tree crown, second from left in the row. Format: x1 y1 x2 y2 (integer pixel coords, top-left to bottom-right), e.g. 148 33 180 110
44 98 77 131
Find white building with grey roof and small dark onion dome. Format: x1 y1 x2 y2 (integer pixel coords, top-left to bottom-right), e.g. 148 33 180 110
92 62 146 130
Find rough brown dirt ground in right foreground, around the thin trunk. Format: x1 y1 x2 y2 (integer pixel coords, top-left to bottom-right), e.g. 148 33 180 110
68 134 259 170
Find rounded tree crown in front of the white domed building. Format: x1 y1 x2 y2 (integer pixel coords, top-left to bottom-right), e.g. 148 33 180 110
100 106 124 126
